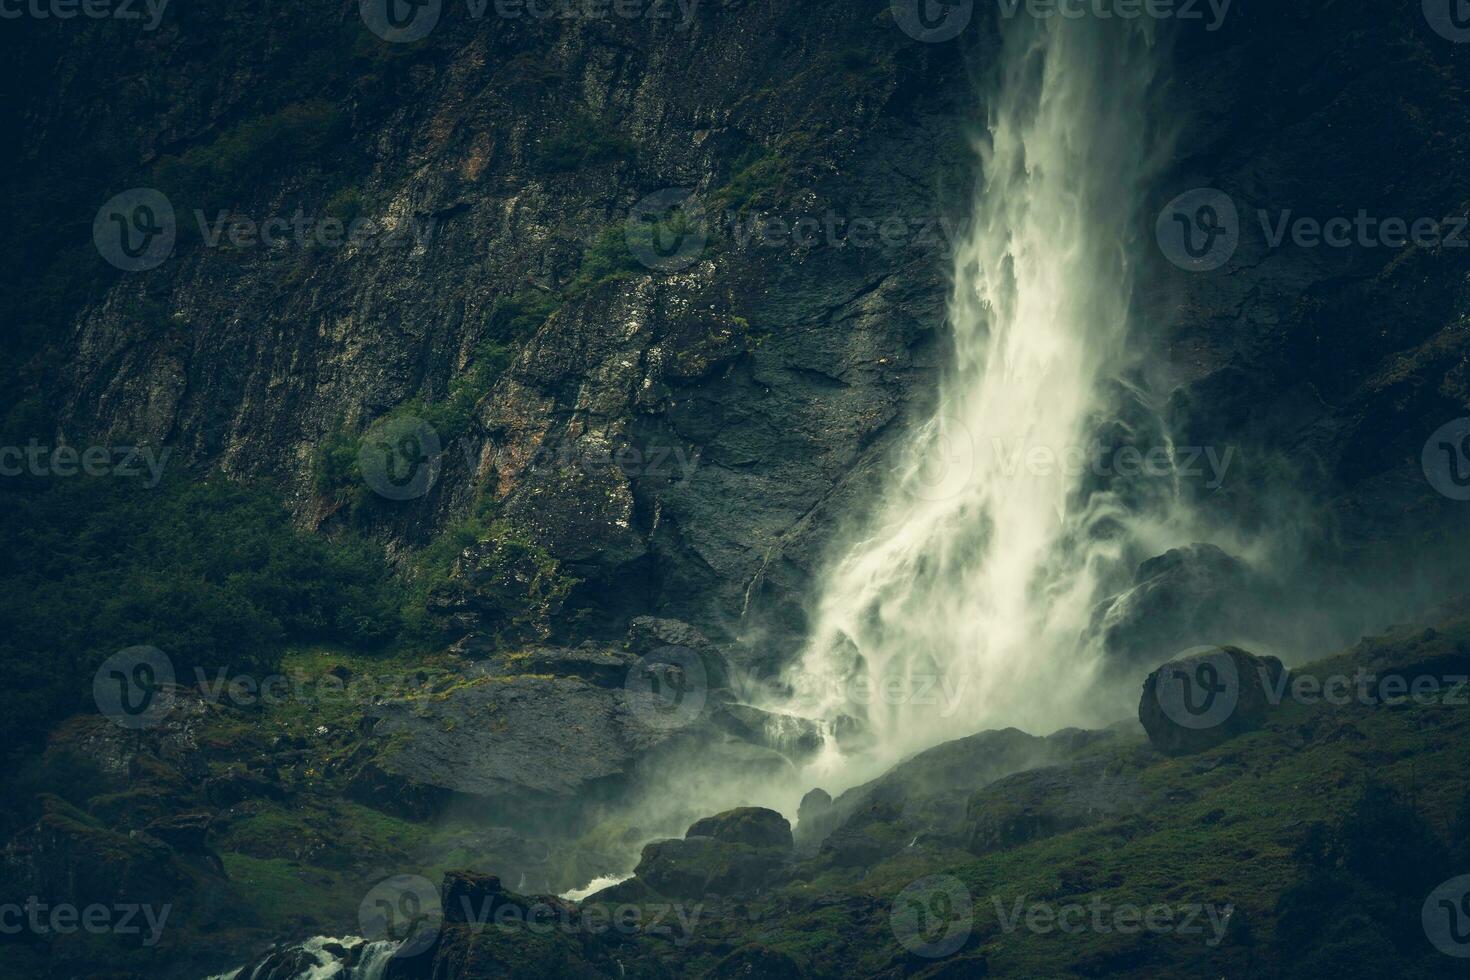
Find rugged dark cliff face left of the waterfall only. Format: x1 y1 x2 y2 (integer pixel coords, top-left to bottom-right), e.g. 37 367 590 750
5 3 975 658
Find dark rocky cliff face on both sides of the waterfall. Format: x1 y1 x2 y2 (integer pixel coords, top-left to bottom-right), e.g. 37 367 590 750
7 0 1470 658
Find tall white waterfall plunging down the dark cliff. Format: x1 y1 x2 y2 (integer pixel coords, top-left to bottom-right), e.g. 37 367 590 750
782 15 1166 785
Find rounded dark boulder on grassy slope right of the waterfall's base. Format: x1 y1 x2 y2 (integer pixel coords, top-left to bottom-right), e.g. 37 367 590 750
1138 646 1288 755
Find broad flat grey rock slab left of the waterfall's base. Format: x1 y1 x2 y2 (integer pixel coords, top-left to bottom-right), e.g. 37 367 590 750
350 669 792 818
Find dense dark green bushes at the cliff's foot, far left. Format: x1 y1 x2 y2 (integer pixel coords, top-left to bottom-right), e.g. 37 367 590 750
0 476 401 746
